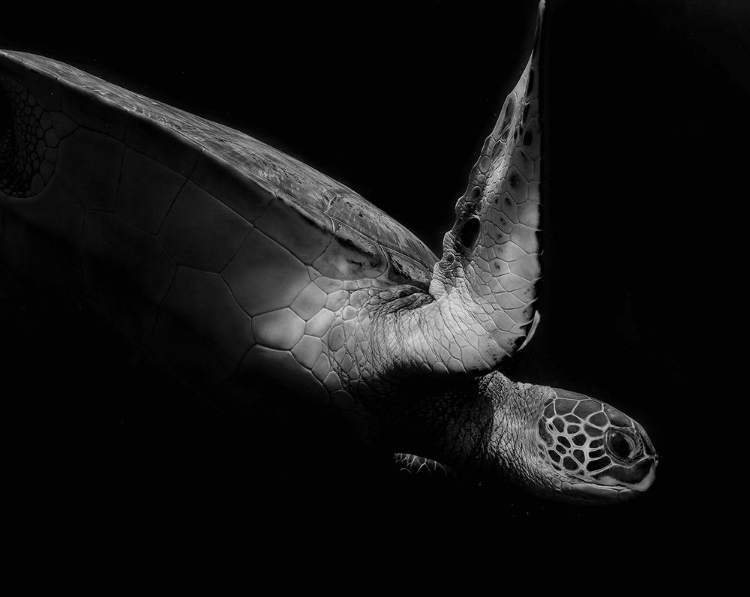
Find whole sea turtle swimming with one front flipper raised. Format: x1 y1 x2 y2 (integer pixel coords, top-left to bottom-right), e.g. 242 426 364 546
0 2 657 503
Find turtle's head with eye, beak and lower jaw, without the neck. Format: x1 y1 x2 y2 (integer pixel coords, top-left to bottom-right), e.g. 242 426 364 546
529 388 658 503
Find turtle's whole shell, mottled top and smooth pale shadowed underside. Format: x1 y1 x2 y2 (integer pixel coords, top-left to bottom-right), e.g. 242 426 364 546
0 52 437 403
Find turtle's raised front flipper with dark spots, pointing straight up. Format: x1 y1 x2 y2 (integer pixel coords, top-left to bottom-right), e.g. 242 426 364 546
430 2 544 373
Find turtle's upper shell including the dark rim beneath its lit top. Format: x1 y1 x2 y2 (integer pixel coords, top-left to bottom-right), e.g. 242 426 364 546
0 51 438 287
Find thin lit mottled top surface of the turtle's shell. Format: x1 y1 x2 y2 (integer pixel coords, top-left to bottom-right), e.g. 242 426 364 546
0 52 437 272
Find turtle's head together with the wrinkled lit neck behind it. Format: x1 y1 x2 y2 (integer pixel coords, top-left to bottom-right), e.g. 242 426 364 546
480 372 658 504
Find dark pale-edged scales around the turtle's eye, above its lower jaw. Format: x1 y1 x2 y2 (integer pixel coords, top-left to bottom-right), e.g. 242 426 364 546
538 390 656 496
